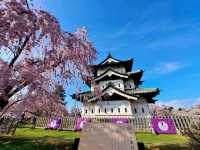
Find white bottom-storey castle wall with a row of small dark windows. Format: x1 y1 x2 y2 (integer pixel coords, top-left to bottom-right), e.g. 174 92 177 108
82 99 150 117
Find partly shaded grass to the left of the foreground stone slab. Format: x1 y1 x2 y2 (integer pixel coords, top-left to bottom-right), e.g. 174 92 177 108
0 128 79 150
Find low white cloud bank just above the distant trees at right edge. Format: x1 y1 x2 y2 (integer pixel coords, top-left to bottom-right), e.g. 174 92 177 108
157 97 200 109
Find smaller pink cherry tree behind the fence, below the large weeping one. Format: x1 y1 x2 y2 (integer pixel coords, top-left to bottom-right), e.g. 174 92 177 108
9 87 68 117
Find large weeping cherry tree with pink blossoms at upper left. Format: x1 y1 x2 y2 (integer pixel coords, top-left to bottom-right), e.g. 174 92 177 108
0 0 96 115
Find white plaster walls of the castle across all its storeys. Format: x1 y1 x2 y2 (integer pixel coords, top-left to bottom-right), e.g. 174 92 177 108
82 60 150 117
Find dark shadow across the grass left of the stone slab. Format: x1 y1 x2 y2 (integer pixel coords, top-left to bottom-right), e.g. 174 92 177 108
0 136 73 150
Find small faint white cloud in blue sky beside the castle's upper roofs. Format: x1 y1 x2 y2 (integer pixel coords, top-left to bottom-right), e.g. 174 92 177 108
153 62 185 74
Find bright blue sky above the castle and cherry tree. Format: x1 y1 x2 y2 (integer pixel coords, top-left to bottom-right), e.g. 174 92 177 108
38 0 200 110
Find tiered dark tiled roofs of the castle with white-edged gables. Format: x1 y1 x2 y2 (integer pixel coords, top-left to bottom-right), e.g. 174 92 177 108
72 54 160 103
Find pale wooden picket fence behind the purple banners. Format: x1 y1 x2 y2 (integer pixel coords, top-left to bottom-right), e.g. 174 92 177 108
36 115 200 133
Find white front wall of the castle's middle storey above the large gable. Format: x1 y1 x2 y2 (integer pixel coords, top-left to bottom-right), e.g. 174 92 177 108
99 79 124 91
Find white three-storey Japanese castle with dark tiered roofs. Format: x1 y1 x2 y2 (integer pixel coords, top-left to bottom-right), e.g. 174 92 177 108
72 54 160 117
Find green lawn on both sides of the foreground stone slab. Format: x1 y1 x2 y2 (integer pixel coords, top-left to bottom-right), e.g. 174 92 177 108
0 128 189 150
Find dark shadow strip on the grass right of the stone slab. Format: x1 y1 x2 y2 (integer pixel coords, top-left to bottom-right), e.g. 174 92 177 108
145 144 190 150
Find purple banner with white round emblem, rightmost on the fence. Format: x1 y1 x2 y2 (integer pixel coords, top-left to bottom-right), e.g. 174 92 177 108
151 118 176 134
